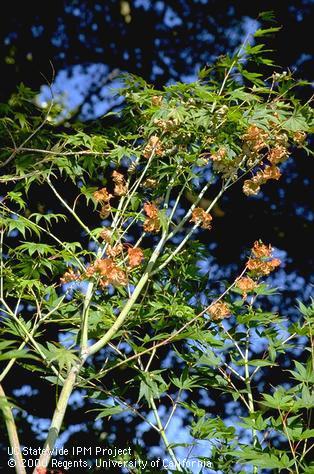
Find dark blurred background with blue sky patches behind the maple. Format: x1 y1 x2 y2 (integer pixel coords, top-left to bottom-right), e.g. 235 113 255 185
0 0 314 472
